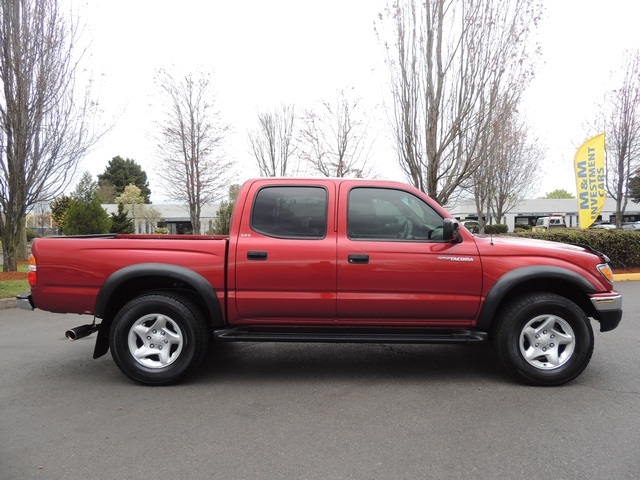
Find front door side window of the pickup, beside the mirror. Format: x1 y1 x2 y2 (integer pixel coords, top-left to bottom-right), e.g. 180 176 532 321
347 188 444 241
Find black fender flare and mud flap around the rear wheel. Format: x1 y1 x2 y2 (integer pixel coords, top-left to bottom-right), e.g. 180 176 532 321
93 263 224 358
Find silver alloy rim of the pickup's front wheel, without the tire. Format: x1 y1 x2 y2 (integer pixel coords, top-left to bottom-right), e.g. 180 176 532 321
519 315 576 370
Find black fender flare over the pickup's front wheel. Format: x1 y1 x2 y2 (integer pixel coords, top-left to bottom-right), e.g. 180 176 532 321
476 265 596 331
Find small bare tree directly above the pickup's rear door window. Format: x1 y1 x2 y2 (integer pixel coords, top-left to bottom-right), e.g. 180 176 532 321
249 105 297 177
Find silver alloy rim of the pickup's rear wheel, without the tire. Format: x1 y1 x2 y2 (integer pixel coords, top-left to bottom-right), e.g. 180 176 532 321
128 313 185 368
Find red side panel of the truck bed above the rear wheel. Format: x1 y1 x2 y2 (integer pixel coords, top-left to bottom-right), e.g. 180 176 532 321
32 234 228 314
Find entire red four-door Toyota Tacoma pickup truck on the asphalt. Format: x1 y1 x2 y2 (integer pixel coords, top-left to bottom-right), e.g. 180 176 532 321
18 178 622 385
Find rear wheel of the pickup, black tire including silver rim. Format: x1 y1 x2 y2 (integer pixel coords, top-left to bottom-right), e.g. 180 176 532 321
109 292 209 385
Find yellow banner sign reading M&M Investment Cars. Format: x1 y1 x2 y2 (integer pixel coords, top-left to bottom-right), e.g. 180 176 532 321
574 133 606 228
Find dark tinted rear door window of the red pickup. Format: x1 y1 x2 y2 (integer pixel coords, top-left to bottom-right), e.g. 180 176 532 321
251 187 327 238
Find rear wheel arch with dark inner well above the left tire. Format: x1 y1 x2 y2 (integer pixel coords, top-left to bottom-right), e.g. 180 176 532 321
93 263 224 358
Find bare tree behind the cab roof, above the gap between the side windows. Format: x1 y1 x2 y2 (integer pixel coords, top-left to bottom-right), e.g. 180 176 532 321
301 90 372 178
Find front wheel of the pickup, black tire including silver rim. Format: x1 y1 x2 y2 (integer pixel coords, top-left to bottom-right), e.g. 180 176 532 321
493 293 593 386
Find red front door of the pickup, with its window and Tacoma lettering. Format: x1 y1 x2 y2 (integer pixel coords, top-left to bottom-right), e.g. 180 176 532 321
337 186 482 326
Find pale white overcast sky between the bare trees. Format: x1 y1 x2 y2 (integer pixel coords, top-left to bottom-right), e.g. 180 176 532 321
78 0 640 203
